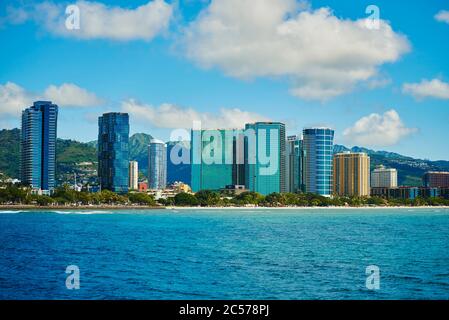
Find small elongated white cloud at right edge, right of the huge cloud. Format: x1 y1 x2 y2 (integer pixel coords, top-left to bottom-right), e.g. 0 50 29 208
402 79 449 100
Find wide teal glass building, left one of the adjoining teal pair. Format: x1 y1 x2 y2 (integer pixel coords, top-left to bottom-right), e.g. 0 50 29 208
191 129 245 192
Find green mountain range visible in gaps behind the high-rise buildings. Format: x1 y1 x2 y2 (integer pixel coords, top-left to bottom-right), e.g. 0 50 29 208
0 129 449 186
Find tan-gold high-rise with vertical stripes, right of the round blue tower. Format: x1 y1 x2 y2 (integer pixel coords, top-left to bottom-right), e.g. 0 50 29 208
333 152 370 197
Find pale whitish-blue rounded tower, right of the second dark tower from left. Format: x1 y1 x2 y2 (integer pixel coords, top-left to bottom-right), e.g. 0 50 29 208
148 139 167 190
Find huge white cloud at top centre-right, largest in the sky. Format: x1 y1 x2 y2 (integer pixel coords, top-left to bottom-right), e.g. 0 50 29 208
182 0 410 100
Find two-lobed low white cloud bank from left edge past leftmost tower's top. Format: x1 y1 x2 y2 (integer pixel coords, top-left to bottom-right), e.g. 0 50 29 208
0 82 103 117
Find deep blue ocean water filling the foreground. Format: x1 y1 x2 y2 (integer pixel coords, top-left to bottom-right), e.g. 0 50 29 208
0 209 449 299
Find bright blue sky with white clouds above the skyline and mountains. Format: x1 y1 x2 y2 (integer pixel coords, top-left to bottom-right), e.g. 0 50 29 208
0 0 449 160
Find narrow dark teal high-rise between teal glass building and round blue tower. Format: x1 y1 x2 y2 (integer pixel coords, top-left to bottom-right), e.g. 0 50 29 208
285 136 303 192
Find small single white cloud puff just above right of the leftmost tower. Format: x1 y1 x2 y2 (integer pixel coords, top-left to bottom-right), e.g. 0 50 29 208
44 83 104 107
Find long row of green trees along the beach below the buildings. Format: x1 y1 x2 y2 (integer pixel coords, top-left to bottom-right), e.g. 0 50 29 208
0 186 449 207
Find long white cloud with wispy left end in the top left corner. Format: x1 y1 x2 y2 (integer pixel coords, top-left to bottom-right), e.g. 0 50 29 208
8 0 173 41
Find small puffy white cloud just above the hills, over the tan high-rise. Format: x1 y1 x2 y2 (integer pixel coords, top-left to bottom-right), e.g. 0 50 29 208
343 109 417 146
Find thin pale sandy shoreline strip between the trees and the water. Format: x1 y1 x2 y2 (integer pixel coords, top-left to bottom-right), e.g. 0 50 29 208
0 205 449 211
